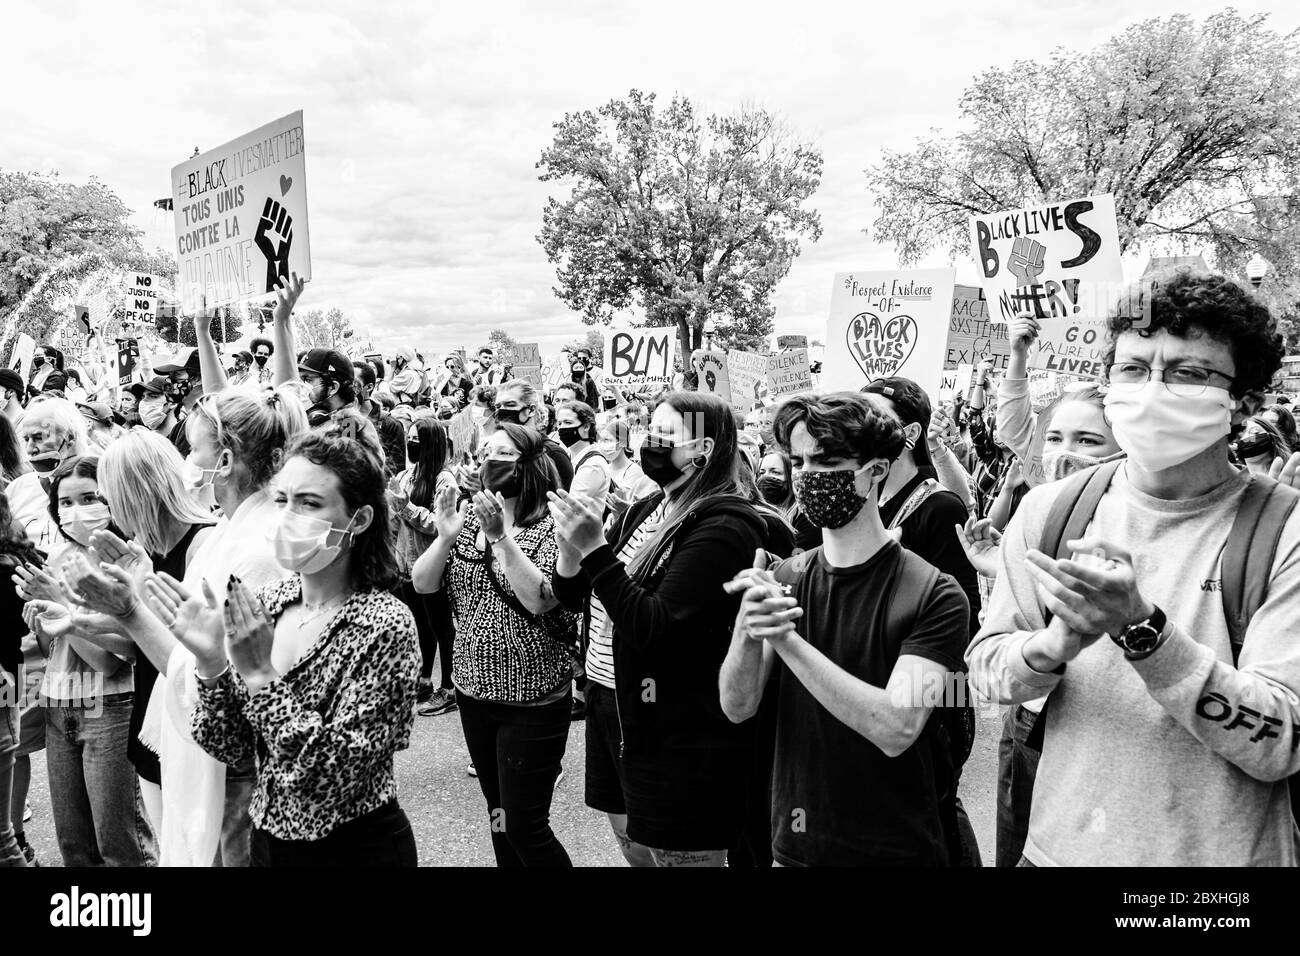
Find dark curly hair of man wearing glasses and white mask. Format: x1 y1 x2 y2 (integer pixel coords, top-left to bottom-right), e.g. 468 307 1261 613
1105 269 1286 398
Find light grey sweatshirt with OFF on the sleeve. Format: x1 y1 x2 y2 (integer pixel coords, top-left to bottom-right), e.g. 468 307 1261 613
966 467 1300 866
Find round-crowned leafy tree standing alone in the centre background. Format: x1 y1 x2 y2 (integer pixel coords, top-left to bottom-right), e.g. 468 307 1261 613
537 90 822 371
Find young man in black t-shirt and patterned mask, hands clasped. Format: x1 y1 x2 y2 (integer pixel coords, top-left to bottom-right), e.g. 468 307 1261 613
719 393 969 866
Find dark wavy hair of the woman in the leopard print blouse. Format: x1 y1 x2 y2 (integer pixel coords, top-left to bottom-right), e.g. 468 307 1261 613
285 429 398 591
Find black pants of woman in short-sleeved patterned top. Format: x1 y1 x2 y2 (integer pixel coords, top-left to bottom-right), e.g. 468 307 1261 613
456 693 573 866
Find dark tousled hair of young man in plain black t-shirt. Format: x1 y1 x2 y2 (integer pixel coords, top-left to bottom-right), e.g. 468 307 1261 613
772 392 904 464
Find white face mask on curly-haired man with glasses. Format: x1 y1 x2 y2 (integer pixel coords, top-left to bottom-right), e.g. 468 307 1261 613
1105 381 1242 471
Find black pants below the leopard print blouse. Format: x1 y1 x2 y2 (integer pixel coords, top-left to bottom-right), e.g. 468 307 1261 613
251 800 416 866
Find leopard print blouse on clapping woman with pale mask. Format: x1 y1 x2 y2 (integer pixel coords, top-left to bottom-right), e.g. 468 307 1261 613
191 575 420 840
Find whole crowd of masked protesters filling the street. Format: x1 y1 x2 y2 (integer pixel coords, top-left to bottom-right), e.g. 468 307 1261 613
0 271 1300 866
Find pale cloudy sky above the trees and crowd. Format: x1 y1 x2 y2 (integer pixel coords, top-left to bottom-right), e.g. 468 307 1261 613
0 0 1300 355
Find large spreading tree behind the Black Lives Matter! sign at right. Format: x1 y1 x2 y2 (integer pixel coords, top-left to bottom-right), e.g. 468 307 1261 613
867 9 1300 272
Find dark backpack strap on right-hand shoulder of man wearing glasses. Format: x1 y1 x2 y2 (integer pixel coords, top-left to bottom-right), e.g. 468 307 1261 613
1219 475 1300 666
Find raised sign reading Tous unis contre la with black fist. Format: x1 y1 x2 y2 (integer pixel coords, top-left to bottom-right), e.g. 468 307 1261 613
172 111 312 312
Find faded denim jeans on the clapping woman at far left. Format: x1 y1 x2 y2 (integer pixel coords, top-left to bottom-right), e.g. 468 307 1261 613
46 693 157 866
